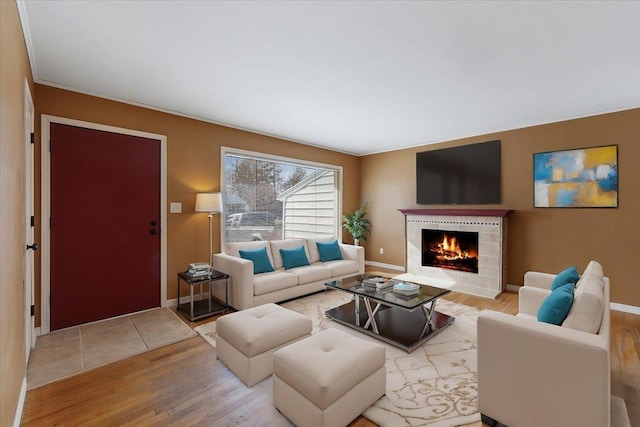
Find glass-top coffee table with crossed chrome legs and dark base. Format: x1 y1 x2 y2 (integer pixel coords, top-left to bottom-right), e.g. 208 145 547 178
325 274 455 353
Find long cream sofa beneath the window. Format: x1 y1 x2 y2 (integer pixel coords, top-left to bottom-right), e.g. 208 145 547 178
213 238 364 310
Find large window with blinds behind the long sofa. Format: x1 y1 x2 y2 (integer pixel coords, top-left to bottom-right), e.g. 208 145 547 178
222 148 342 243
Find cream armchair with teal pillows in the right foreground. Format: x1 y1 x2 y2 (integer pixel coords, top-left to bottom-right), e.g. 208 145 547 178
478 261 611 427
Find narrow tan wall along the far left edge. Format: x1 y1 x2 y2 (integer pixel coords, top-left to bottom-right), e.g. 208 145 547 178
0 1 33 426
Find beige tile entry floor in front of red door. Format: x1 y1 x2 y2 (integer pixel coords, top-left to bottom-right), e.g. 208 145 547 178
27 308 197 389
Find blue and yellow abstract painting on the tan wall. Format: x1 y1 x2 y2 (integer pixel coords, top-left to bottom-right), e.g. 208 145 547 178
533 145 618 208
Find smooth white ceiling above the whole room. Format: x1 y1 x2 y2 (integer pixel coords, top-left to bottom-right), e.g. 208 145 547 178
18 0 640 155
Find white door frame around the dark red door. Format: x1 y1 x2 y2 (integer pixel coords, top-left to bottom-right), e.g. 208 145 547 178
40 114 167 334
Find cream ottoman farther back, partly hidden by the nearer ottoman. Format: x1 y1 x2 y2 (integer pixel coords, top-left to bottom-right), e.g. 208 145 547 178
216 304 312 387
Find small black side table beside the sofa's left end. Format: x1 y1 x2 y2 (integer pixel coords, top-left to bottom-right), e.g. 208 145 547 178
178 270 229 322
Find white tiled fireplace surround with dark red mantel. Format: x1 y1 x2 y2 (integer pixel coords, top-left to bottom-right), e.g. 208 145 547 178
400 209 510 298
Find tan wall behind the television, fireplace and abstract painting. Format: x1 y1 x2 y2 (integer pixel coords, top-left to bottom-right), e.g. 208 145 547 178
361 109 640 306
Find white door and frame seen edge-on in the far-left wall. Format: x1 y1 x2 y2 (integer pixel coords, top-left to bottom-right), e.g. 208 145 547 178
23 78 36 363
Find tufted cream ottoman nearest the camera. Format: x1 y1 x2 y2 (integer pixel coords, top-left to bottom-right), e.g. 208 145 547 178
273 329 387 427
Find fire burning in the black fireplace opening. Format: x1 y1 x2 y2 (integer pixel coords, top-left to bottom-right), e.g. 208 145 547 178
422 228 478 274
